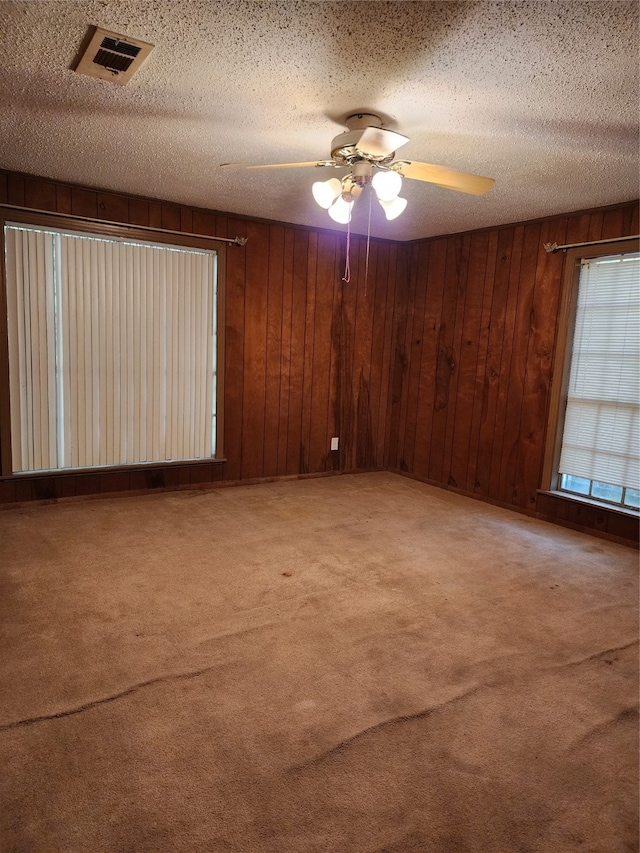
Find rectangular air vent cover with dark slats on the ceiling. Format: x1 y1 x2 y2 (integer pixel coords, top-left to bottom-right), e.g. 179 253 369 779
76 27 153 85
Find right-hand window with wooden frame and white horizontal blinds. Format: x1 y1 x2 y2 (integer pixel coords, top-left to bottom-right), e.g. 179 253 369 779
550 243 640 511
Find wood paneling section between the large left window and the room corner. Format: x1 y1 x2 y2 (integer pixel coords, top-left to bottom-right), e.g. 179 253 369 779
222 219 398 480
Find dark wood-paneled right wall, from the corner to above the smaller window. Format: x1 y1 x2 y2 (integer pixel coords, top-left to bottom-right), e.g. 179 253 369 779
386 198 638 535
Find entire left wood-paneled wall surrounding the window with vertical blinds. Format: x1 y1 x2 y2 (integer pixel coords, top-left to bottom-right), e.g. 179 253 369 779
0 171 401 503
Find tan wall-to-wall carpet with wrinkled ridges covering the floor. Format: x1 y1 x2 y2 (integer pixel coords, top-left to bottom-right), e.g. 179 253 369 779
0 473 638 853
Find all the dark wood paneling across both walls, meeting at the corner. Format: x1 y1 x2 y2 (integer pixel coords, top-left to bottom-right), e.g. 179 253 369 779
0 171 639 538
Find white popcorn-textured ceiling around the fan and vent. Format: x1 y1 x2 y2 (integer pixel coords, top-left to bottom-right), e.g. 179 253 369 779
0 0 638 240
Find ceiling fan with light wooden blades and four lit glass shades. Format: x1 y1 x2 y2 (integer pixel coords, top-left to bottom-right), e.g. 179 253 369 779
221 113 494 224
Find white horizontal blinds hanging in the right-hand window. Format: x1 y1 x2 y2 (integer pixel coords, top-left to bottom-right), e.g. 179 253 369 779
559 253 640 489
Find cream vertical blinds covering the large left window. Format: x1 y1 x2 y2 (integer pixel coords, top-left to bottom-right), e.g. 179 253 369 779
5 225 216 473
